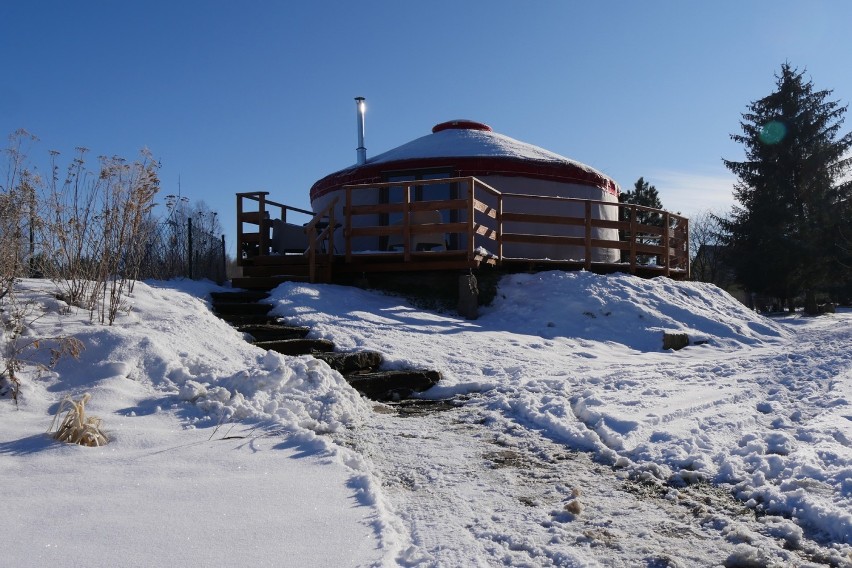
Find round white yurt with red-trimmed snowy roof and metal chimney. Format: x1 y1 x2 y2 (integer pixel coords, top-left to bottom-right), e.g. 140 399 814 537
310 120 619 262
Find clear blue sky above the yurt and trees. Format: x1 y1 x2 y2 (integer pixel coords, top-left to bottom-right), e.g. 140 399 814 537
0 0 852 253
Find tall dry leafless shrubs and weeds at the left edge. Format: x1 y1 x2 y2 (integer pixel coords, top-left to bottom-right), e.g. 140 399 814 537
0 130 226 403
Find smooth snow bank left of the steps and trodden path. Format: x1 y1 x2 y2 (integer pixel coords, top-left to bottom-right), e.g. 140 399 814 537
0 280 381 566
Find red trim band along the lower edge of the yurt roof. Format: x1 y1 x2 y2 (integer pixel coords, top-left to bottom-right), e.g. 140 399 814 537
311 156 618 202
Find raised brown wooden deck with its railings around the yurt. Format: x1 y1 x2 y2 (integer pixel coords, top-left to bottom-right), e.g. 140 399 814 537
233 178 689 289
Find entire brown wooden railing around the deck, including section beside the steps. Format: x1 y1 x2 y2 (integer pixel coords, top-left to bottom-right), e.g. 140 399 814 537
237 177 689 282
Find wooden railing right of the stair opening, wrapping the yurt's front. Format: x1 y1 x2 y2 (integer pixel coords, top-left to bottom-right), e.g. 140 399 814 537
343 177 689 275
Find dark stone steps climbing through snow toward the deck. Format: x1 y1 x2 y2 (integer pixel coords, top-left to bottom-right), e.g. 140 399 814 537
211 290 441 401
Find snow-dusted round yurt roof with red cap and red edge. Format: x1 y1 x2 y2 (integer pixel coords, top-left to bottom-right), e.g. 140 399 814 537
311 119 619 200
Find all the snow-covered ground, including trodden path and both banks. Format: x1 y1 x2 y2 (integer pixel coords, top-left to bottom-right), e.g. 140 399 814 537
0 272 852 566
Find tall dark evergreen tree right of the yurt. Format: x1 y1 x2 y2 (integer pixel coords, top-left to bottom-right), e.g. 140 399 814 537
722 63 852 307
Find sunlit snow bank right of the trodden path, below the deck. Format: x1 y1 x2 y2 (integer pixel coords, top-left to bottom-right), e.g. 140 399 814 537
276 272 852 560
